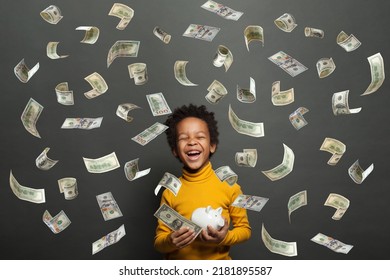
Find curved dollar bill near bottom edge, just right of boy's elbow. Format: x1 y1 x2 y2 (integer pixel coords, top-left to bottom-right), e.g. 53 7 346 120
261 223 298 257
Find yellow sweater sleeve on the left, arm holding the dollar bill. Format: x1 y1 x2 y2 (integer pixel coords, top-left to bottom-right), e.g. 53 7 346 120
154 190 176 254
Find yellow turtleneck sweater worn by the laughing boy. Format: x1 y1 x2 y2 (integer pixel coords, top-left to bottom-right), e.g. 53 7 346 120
154 162 251 260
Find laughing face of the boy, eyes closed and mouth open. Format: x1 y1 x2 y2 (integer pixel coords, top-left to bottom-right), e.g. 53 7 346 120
172 117 217 170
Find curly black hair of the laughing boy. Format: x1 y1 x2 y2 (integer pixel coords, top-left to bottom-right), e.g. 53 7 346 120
164 104 219 157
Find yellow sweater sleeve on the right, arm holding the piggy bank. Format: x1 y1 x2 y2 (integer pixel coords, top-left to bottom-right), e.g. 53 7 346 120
220 184 251 246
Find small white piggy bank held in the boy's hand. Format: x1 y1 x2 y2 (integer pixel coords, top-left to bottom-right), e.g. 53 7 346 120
191 206 225 230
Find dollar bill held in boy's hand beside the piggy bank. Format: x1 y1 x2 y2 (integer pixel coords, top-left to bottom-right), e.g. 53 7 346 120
154 203 202 237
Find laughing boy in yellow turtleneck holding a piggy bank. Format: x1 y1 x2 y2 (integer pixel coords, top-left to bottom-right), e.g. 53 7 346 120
154 104 251 260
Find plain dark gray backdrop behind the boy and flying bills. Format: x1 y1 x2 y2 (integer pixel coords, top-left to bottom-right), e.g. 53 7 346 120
0 0 390 259
